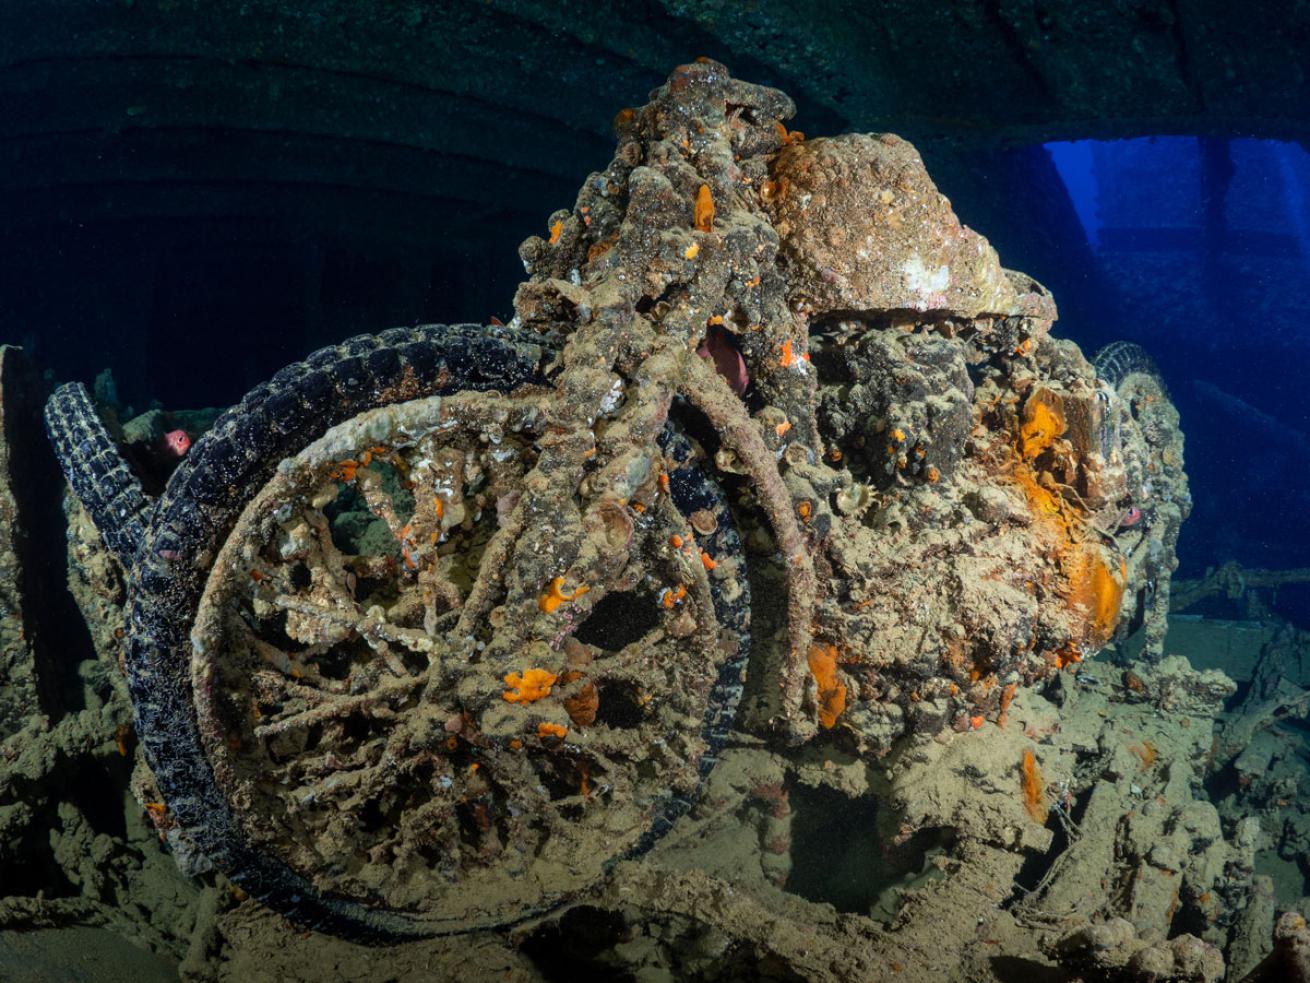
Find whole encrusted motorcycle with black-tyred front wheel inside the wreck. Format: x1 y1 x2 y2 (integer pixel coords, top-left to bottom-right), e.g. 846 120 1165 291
47 60 1188 938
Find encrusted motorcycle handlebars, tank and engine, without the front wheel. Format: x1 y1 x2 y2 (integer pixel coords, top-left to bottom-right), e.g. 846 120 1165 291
516 62 1189 750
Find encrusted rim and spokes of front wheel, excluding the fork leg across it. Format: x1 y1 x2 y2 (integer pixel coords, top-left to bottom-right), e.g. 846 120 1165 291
191 392 745 928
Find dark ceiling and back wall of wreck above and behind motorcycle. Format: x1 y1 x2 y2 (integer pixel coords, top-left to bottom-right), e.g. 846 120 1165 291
0 0 1310 398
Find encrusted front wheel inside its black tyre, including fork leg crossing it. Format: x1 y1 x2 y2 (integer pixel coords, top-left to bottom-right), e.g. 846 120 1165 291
188 393 738 927
